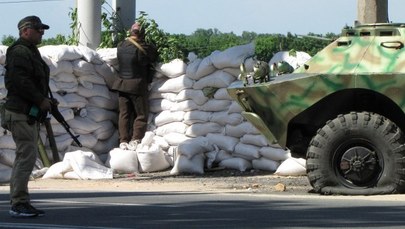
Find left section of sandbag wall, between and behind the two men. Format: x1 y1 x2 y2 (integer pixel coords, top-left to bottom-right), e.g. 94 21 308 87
0 45 118 168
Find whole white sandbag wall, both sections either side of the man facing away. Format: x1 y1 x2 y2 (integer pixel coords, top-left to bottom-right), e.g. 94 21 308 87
0 44 304 180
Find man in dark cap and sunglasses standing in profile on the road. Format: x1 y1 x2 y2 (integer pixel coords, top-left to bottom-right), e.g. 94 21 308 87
4 16 52 217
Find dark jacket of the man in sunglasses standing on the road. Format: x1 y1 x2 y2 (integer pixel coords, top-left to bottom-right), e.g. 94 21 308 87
4 38 49 114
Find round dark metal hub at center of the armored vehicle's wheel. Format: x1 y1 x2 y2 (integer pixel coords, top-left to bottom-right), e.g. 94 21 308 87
340 146 378 185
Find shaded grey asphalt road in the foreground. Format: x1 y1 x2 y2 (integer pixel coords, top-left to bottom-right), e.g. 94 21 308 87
0 187 405 229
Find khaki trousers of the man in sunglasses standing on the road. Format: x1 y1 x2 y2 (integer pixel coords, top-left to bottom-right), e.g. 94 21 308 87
4 110 39 205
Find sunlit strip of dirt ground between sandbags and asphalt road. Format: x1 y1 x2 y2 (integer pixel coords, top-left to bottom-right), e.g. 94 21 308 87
0 169 312 194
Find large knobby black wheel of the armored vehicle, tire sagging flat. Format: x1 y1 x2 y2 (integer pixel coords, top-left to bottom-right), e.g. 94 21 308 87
307 112 405 195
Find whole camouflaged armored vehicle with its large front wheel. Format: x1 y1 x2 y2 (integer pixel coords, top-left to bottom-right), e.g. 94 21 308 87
228 24 405 195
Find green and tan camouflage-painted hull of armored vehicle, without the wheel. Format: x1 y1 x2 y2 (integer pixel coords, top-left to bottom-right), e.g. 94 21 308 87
228 24 405 146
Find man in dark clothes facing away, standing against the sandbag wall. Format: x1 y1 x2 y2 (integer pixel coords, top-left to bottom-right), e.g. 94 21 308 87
112 22 158 150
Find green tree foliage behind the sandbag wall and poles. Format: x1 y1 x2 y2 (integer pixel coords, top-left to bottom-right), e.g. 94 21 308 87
1 5 337 63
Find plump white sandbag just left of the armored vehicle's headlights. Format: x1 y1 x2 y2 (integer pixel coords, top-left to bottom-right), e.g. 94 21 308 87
193 70 235 90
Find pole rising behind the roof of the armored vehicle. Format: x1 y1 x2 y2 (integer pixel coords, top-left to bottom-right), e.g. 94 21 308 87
357 0 389 24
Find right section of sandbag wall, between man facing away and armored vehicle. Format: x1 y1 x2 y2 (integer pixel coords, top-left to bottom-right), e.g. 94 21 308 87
145 44 290 174
